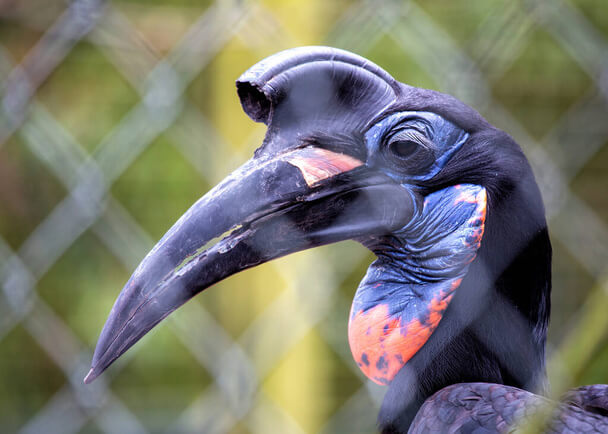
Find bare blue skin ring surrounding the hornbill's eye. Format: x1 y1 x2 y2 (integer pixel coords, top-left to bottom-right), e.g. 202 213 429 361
365 111 469 183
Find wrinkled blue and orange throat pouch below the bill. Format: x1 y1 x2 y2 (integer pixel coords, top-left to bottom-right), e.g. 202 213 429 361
348 185 486 385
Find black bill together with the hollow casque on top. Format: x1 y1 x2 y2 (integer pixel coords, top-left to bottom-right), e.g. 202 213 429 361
85 48 408 383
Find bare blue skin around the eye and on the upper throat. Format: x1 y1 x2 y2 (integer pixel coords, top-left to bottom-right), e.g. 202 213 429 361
353 112 485 324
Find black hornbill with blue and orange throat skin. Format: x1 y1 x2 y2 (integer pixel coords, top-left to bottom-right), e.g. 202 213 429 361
85 47 608 433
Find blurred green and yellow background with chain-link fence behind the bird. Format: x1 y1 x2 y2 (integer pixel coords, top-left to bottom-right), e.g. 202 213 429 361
0 0 608 433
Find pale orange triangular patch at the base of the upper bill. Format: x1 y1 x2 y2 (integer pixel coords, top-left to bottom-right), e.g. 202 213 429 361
285 146 363 187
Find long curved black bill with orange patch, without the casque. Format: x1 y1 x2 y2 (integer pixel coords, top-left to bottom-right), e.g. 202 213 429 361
85 146 416 383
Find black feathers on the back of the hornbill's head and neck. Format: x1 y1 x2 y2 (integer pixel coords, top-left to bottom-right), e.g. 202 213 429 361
378 94 551 433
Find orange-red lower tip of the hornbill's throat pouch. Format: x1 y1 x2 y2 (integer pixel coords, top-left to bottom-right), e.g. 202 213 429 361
348 294 460 385
